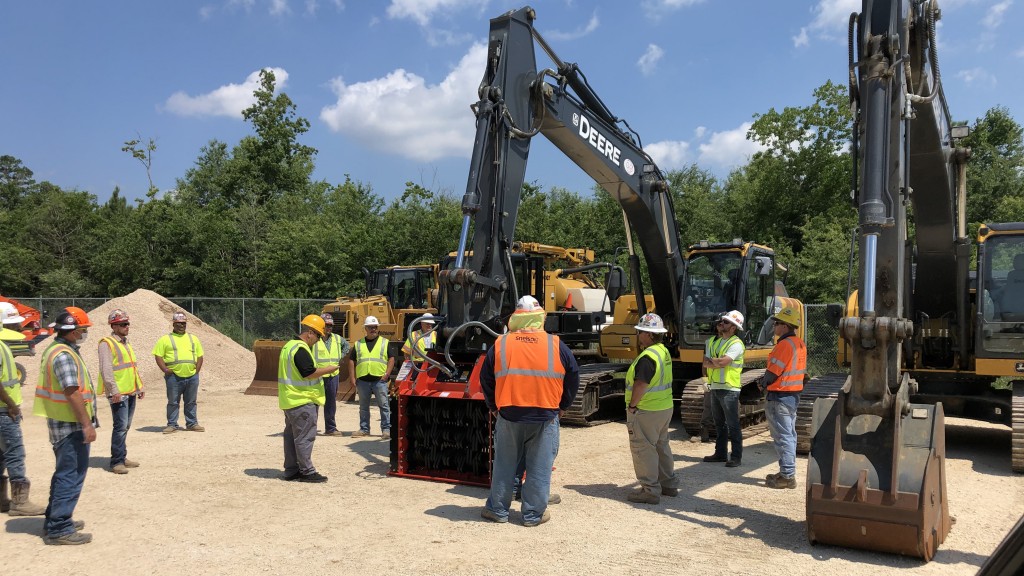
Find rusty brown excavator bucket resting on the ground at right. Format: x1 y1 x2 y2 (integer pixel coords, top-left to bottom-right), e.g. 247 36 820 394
807 393 950 562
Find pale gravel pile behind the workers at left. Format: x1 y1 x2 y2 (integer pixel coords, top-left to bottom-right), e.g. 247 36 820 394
19 289 256 395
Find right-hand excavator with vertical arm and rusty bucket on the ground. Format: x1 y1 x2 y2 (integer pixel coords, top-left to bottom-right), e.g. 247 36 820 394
806 0 1024 561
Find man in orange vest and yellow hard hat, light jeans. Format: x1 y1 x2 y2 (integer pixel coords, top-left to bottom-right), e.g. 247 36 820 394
758 305 807 488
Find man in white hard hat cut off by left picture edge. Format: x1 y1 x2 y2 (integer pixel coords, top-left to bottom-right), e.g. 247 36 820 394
0 302 46 516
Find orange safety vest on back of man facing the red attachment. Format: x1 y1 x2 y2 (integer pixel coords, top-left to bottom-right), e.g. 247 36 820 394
495 330 565 410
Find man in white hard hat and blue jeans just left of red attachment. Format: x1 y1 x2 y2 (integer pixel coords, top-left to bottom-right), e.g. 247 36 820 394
348 316 394 440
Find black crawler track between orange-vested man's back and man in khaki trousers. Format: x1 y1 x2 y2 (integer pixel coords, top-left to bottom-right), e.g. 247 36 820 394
561 363 630 426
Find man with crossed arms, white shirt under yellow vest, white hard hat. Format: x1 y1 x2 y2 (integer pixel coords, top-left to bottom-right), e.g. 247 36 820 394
701 310 746 468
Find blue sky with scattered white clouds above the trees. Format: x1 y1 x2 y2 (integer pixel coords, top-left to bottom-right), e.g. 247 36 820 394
0 0 1024 202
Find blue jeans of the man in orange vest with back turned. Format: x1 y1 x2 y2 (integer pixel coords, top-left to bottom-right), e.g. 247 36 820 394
484 415 558 524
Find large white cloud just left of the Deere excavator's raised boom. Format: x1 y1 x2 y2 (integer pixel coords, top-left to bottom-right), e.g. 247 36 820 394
319 44 486 162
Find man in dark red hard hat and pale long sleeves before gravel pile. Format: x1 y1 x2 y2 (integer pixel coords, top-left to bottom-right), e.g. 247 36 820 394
96 308 145 474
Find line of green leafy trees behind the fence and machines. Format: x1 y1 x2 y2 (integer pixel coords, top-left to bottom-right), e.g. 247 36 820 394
0 71 1024 302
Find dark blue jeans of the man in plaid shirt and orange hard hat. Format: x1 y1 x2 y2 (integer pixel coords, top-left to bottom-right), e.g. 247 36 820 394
43 430 89 538
